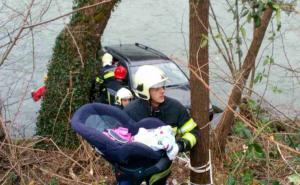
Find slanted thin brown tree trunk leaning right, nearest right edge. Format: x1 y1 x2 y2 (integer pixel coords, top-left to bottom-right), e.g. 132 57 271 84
214 7 273 154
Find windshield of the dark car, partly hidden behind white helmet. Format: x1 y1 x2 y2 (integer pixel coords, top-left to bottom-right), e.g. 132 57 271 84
130 62 188 87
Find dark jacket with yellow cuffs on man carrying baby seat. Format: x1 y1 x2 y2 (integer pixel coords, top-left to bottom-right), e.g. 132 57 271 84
124 96 198 151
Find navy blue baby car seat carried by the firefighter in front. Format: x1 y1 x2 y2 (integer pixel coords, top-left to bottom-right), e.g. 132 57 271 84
71 103 172 184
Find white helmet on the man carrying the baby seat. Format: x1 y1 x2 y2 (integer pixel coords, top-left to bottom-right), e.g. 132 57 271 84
134 65 168 100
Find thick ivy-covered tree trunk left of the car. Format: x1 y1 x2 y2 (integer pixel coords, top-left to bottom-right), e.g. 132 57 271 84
37 0 117 147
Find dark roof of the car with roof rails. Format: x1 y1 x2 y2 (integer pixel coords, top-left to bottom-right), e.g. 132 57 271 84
104 43 169 63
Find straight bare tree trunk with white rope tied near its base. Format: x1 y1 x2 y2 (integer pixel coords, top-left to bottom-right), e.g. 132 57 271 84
189 0 209 184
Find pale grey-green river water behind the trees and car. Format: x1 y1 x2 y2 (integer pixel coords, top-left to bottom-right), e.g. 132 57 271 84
0 0 300 137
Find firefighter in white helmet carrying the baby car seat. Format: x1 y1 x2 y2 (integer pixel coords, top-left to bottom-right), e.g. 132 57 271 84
124 65 198 184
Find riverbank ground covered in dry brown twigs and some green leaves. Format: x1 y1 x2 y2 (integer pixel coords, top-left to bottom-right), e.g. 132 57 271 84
0 116 300 185
